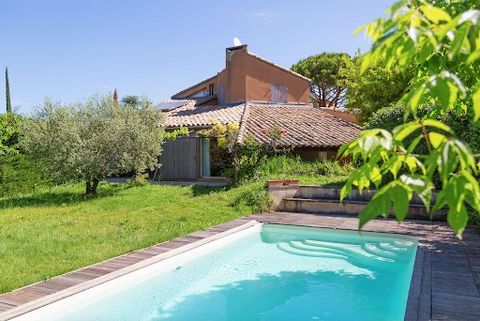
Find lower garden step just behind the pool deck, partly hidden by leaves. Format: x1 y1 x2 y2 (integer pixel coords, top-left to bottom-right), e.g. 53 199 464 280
283 197 445 219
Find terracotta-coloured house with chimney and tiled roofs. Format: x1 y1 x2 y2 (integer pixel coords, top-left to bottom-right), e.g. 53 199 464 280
155 45 360 181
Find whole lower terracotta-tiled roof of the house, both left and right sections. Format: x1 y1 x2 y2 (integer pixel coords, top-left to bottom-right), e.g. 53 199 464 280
165 102 361 147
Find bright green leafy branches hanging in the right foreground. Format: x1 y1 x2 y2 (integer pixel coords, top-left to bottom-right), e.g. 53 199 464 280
339 0 480 237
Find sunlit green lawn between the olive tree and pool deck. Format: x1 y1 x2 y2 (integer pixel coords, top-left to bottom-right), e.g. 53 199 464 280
0 183 266 293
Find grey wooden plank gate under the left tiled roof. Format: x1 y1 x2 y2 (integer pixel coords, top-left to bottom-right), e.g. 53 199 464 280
155 137 198 180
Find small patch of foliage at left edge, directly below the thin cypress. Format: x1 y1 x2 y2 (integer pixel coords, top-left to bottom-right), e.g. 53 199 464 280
0 113 23 157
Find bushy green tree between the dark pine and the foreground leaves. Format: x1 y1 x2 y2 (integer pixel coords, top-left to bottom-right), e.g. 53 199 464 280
346 54 412 123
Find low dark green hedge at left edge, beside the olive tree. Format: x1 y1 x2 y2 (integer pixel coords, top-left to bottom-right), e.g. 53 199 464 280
0 153 50 197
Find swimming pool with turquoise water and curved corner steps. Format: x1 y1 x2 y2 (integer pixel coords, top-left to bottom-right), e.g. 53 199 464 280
9 224 417 321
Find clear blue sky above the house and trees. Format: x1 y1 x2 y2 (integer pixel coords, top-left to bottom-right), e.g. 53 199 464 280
0 0 391 113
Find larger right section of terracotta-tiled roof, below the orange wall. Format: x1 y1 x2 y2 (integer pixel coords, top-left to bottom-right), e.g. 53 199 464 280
239 104 361 147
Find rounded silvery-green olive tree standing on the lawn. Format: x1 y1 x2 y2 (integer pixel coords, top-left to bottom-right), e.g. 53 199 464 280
22 97 163 194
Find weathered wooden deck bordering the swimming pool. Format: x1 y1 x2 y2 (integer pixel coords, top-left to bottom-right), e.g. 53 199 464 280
0 213 480 321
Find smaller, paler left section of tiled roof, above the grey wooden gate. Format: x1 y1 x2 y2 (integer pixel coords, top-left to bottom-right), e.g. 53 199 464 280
165 104 245 127
